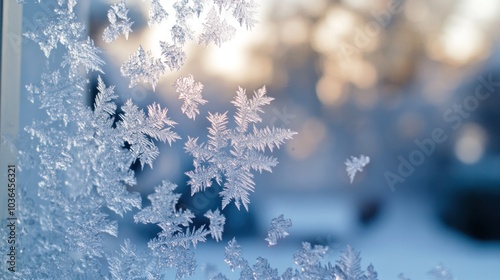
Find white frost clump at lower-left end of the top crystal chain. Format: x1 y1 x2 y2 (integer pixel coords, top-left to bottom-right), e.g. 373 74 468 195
120 46 165 90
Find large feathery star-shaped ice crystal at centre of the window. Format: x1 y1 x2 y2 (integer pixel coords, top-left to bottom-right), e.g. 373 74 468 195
185 87 296 211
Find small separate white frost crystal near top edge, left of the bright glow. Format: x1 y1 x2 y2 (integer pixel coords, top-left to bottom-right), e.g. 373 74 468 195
102 0 134 43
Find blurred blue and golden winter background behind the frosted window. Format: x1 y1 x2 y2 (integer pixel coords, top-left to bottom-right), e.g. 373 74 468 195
23 0 500 279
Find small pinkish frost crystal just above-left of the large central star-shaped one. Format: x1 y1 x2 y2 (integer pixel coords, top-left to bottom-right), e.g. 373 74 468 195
174 75 207 120
